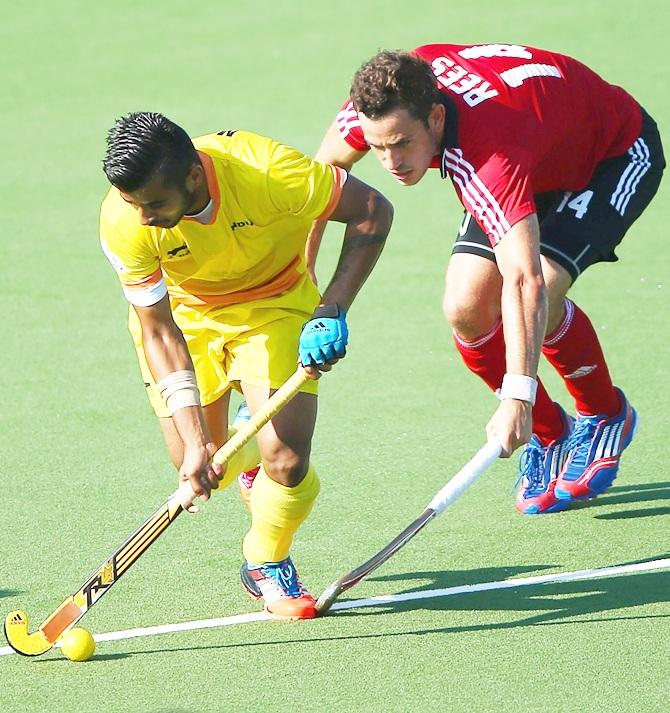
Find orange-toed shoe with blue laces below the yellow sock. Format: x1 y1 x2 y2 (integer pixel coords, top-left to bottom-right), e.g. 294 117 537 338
240 557 316 619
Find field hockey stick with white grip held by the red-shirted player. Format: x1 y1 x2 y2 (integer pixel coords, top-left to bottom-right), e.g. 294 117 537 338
316 441 502 615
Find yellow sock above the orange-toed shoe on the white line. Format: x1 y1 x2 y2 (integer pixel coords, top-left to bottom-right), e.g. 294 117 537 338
242 465 320 564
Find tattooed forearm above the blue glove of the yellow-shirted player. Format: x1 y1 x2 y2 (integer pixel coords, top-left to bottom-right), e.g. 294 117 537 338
322 190 393 310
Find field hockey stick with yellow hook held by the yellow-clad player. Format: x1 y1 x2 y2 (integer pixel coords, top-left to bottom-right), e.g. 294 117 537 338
5 367 309 656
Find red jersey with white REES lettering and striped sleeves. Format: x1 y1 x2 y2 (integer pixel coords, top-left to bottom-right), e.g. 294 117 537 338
337 44 642 246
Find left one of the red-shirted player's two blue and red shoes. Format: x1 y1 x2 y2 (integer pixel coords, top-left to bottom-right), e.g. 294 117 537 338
516 404 574 515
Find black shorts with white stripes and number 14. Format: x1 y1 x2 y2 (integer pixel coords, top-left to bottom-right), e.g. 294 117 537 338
452 109 665 281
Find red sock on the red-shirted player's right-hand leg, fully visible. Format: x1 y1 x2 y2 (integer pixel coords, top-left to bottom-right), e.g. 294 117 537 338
542 298 620 416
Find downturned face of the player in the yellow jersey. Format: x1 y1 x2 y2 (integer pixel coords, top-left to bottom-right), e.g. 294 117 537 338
121 168 202 229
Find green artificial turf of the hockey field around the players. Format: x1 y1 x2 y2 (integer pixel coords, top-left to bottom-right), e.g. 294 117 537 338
0 0 670 713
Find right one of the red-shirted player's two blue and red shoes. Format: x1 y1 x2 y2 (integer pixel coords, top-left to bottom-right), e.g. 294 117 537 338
555 389 639 502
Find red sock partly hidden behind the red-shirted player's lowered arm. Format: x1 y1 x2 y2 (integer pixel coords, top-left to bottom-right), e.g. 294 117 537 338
454 321 564 445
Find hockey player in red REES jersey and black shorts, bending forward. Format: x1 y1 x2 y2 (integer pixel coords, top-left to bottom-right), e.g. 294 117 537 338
307 44 665 514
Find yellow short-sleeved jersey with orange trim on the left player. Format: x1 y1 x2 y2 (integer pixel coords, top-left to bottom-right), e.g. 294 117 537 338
100 131 347 307
